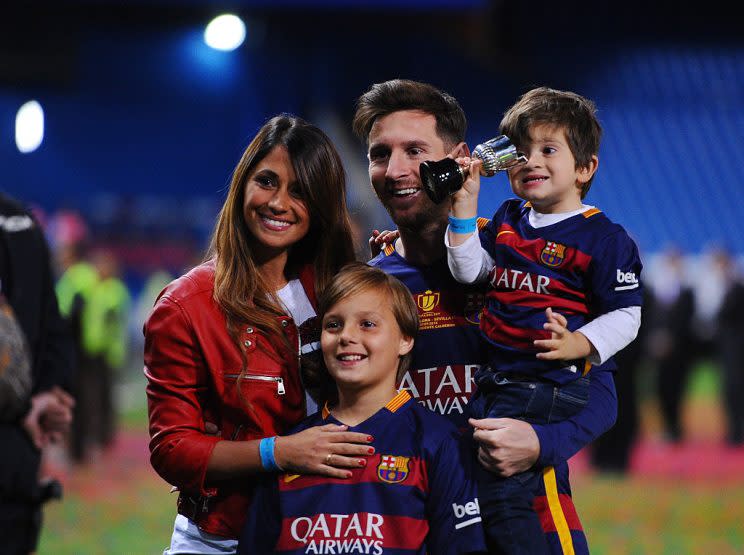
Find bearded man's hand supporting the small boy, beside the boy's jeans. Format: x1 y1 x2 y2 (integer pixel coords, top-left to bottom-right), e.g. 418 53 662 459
469 418 540 478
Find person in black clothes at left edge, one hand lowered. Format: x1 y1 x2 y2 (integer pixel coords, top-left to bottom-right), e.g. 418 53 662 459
0 194 74 555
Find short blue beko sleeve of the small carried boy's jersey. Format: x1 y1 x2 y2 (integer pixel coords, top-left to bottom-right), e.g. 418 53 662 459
590 228 643 314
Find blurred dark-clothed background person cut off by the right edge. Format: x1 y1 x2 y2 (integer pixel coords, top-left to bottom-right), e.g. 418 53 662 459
713 249 744 445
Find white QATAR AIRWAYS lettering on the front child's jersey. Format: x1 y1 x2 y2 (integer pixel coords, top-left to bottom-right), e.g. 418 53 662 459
289 513 385 554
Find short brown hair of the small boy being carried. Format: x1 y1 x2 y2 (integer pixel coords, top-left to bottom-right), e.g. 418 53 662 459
500 87 602 198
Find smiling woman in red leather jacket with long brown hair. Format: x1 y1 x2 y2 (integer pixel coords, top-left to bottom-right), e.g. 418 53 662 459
145 115 373 554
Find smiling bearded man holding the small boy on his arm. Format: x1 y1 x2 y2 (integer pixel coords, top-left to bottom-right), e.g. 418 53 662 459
353 79 617 553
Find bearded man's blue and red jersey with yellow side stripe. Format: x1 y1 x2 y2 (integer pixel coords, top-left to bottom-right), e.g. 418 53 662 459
369 243 617 555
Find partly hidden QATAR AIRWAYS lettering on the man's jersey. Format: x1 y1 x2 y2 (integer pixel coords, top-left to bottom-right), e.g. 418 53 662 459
400 364 480 415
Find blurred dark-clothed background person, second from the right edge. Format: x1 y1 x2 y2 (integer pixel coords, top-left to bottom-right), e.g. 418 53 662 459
643 247 698 443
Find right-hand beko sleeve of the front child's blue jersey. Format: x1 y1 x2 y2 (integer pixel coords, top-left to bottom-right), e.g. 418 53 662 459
426 430 486 555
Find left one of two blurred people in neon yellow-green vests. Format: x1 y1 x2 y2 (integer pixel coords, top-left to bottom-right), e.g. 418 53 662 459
56 241 100 463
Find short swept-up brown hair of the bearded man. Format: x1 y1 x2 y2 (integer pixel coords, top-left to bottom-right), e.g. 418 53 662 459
352 79 468 146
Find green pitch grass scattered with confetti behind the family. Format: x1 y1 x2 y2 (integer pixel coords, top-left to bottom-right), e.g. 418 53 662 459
38 364 744 555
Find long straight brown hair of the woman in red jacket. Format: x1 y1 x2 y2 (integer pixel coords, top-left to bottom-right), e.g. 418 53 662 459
203 114 354 358
